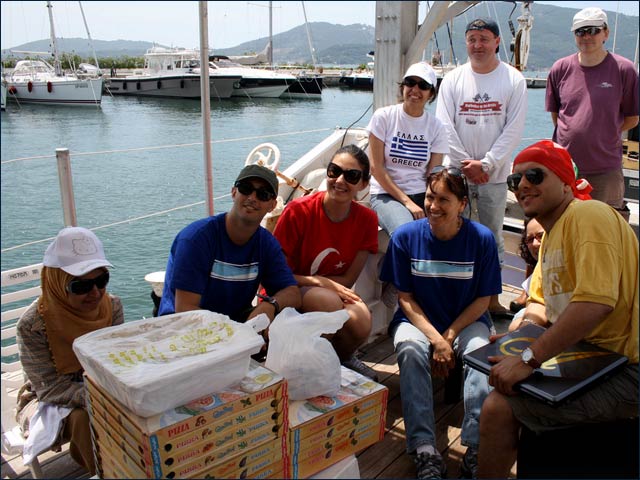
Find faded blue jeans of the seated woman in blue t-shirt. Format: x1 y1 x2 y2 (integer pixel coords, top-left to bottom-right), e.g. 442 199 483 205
393 322 489 454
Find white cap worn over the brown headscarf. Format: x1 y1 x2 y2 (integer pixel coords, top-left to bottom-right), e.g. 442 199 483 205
42 227 113 277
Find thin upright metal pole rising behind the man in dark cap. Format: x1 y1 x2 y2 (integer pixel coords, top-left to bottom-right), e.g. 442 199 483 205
198 0 213 216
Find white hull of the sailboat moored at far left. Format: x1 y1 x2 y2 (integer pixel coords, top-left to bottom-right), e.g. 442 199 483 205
7 77 102 106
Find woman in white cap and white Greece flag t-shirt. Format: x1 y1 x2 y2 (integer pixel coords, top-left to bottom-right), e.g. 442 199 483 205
367 62 449 235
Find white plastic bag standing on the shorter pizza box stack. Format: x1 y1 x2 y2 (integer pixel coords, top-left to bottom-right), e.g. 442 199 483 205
265 308 349 400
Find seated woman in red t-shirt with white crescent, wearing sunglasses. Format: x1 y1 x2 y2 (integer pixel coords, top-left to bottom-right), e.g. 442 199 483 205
273 145 378 380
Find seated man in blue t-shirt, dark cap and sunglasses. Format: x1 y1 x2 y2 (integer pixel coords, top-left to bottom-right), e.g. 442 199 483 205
159 165 300 322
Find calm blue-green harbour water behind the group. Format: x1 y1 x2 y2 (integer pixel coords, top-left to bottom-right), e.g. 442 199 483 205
0 88 552 320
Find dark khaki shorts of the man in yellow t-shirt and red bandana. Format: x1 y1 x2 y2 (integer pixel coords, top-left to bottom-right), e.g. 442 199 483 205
506 363 638 433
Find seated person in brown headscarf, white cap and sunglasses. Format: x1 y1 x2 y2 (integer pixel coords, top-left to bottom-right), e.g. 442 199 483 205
16 227 124 475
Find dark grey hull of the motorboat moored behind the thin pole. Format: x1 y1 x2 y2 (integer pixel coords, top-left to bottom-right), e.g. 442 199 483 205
107 75 240 99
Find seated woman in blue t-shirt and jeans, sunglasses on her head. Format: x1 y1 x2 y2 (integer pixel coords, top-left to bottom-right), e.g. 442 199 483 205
380 166 502 478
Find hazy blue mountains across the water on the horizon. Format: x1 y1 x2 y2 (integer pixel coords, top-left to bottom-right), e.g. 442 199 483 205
2 2 638 70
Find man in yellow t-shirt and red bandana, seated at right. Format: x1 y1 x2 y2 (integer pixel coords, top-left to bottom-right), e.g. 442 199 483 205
478 140 639 478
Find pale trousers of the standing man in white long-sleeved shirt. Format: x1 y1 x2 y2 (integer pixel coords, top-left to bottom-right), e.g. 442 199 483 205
464 183 507 265
